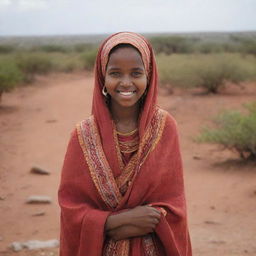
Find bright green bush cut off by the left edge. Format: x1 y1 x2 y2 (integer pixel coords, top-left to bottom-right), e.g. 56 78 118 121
0 62 23 101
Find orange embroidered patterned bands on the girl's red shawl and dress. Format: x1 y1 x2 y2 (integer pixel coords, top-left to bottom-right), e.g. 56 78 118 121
77 109 166 256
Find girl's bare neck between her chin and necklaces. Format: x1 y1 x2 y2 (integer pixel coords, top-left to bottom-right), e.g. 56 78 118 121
110 102 139 124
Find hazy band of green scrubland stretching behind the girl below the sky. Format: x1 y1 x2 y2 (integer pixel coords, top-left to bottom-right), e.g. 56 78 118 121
0 33 256 103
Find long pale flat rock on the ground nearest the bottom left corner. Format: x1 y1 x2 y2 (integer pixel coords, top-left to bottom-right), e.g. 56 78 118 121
10 239 59 252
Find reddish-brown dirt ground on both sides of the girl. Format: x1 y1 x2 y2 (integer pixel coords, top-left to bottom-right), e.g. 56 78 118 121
0 73 256 256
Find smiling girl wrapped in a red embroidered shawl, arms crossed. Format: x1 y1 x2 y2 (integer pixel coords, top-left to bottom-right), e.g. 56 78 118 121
58 32 192 256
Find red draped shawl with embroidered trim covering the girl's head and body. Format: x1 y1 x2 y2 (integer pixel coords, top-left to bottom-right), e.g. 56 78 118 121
58 32 192 256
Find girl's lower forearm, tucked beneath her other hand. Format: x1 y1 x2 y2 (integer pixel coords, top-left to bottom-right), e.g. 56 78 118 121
107 225 154 241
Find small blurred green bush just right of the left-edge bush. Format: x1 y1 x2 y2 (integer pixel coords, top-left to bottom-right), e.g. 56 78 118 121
16 54 54 82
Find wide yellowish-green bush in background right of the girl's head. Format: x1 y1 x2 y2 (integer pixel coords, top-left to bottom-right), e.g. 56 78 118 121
157 54 256 93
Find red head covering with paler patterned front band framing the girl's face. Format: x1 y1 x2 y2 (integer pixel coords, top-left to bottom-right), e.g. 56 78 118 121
92 32 158 175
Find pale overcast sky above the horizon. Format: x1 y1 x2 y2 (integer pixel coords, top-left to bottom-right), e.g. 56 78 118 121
0 0 256 35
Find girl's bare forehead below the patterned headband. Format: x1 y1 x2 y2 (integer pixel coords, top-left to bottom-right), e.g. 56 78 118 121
107 47 144 68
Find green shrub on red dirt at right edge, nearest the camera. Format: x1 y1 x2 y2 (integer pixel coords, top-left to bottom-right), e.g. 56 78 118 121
196 102 256 160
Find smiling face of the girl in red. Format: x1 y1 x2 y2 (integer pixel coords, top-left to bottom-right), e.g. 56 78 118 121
105 47 147 107
